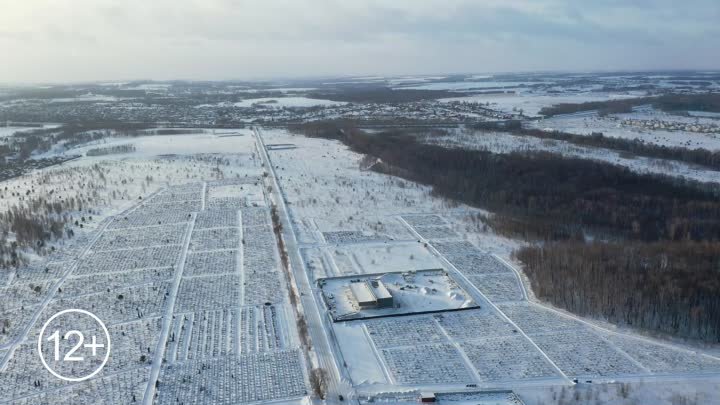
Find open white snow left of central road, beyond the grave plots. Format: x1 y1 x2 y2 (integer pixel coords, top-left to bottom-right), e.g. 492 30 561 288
0 131 261 246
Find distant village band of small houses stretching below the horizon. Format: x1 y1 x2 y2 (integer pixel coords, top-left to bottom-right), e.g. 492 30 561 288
0 97 521 127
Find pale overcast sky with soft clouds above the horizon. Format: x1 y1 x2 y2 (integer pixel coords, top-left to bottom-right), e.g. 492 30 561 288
0 0 720 83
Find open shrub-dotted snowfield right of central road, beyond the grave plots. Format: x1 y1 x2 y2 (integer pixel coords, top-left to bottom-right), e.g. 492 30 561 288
263 129 490 237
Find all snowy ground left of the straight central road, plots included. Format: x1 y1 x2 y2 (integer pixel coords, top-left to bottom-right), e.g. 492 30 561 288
0 131 309 404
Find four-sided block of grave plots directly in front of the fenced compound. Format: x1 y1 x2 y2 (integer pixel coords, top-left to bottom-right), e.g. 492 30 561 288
364 309 560 385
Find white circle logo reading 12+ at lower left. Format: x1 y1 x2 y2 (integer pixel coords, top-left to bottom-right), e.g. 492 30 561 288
38 309 110 382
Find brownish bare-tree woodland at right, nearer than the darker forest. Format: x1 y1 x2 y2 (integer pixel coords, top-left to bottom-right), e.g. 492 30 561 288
516 242 720 342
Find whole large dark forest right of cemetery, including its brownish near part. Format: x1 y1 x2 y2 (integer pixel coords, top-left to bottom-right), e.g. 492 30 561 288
294 122 720 341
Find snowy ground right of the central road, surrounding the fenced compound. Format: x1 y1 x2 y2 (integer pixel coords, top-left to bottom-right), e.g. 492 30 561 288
263 130 720 403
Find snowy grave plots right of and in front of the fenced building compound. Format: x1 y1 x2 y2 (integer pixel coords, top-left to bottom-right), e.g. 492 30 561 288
365 214 720 385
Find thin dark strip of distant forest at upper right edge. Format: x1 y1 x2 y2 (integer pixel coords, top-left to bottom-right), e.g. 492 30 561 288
540 93 720 117
